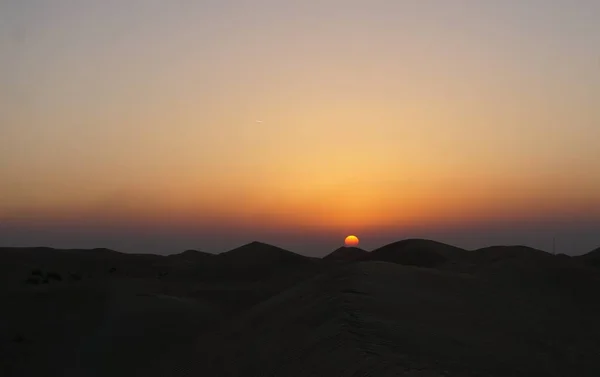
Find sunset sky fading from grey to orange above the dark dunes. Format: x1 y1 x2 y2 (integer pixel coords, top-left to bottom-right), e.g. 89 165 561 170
0 0 600 256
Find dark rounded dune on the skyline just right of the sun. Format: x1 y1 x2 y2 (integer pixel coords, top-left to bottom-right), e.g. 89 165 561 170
362 239 467 267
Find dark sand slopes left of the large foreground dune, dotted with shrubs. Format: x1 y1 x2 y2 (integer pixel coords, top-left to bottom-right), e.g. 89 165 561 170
0 245 328 377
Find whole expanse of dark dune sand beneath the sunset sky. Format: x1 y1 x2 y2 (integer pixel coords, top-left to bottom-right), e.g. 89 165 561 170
0 245 600 377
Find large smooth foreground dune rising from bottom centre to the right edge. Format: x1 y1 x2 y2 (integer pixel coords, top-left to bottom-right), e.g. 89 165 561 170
182 262 600 377
